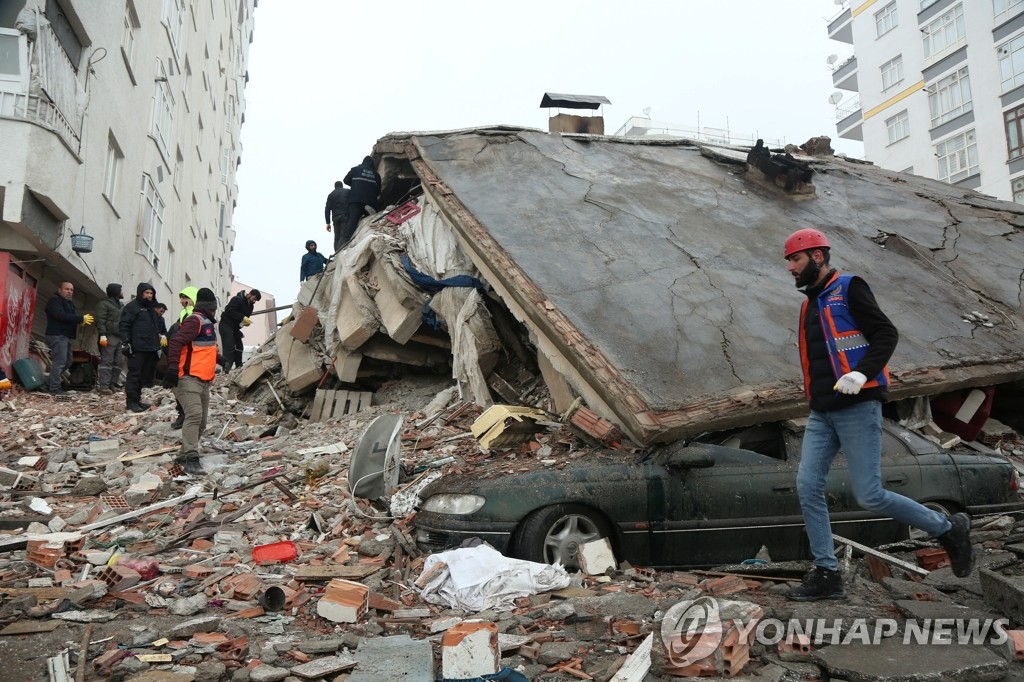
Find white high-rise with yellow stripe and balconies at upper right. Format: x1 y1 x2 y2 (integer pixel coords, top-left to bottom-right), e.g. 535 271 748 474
828 0 1024 203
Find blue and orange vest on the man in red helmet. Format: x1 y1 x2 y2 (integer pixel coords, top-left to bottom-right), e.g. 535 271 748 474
800 273 889 399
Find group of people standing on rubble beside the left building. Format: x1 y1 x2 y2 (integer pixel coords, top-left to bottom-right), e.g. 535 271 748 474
46 282 261 473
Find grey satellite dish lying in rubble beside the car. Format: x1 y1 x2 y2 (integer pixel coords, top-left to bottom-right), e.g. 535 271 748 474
348 415 404 500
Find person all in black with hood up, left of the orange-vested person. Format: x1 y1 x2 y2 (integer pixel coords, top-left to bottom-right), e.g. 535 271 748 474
118 282 160 412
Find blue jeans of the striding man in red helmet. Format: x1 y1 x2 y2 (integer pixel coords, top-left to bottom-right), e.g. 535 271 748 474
797 400 950 570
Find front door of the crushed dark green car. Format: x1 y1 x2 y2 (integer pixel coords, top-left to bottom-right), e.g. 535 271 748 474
648 438 803 566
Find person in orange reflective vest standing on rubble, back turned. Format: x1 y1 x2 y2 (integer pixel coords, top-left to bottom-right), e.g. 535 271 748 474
163 287 220 474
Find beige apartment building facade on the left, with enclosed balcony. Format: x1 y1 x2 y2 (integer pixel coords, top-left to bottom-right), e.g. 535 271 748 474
0 0 256 339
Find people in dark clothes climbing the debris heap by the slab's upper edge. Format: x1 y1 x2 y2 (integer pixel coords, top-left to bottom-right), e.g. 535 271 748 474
299 157 381 282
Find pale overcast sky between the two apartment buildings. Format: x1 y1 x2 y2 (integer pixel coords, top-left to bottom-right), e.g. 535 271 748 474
231 0 863 305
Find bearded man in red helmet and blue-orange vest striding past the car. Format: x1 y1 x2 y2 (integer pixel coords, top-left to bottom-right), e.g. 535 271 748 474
784 229 974 601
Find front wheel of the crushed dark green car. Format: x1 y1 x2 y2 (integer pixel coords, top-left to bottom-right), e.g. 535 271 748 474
515 505 611 570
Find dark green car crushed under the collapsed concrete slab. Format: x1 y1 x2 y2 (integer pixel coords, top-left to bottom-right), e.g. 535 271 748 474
414 419 1024 568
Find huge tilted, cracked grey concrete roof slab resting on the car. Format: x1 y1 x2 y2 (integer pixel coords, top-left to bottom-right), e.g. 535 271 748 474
376 127 1024 443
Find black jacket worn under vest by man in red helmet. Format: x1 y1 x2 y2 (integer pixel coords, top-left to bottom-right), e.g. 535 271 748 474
803 274 899 412
